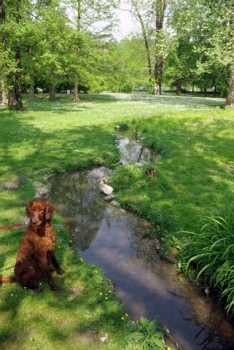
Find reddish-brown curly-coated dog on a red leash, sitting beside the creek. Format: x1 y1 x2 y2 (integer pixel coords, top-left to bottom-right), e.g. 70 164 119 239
0 198 64 291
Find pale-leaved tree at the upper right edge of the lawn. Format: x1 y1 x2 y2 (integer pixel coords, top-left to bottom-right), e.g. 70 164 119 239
173 0 234 104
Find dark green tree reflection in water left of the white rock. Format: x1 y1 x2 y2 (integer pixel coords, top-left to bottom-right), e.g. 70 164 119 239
50 171 105 250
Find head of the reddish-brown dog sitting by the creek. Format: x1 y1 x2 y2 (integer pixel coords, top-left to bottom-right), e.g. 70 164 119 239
26 198 54 226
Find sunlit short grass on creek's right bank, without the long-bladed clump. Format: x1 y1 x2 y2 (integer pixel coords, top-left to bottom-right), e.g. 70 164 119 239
112 110 234 235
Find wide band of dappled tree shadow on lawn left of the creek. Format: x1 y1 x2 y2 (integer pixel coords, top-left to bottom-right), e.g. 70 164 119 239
0 109 118 181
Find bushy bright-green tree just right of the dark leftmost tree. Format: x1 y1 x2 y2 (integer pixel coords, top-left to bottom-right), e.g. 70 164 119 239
34 1 73 101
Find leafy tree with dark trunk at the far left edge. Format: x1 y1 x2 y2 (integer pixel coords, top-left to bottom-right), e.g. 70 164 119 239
1 0 42 110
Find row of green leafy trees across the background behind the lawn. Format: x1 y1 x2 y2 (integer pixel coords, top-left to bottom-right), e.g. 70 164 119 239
0 0 234 109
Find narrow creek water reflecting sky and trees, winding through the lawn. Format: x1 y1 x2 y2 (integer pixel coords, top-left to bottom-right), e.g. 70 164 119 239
49 138 234 350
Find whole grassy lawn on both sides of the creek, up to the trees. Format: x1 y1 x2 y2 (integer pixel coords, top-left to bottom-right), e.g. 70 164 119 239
0 94 234 350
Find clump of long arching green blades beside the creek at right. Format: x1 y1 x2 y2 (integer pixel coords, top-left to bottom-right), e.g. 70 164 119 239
186 205 234 314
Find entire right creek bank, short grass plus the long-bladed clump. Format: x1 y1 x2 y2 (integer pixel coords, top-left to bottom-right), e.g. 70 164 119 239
112 102 234 314
